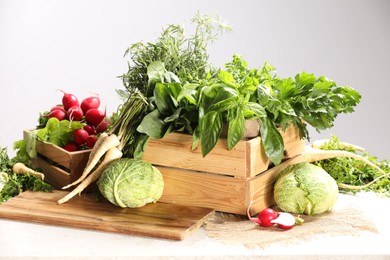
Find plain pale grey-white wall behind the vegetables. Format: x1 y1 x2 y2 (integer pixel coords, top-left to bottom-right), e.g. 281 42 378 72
0 0 390 159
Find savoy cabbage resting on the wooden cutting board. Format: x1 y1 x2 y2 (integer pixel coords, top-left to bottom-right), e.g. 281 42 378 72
97 158 164 208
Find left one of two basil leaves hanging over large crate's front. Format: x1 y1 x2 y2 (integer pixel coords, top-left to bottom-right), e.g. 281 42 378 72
200 111 222 157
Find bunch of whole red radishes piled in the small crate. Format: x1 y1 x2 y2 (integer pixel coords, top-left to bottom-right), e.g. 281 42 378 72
47 90 110 152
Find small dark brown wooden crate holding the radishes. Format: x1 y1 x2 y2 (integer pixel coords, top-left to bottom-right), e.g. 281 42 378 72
23 130 90 188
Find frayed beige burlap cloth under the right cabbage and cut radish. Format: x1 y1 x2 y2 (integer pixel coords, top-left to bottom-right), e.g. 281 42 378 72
205 194 378 248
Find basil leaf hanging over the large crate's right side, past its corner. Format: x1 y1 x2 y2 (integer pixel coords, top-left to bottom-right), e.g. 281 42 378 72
260 117 284 165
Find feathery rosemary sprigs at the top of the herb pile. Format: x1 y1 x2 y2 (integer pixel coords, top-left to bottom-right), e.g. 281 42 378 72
117 13 231 97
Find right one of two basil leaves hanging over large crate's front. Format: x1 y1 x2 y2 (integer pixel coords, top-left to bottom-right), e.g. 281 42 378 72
227 107 245 150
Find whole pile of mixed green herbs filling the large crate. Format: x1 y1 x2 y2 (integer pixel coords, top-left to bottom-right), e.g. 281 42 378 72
118 14 361 164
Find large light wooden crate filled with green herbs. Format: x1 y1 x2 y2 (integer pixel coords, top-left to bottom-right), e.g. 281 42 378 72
143 126 305 214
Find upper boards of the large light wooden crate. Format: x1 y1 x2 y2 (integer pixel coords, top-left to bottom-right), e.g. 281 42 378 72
143 125 305 179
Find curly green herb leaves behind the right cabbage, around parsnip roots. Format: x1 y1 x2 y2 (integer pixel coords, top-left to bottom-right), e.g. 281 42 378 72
315 136 390 196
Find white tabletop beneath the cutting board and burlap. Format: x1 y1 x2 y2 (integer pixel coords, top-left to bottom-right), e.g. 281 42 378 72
0 192 390 259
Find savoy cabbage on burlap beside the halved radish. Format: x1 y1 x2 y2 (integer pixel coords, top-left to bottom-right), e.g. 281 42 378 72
274 162 339 215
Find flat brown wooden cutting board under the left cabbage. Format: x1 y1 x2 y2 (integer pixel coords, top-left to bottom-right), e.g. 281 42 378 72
0 190 214 240
